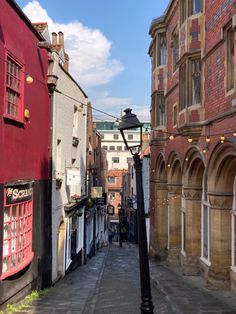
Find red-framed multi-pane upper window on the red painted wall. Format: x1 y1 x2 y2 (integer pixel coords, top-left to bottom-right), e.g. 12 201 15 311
3 49 24 123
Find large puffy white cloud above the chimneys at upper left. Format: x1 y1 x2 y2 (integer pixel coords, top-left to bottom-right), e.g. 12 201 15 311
23 0 124 88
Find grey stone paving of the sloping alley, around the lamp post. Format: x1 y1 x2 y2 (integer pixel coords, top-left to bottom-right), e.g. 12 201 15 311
12 242 236 314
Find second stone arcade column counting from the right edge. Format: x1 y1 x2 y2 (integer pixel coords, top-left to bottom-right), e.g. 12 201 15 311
181 187 202 276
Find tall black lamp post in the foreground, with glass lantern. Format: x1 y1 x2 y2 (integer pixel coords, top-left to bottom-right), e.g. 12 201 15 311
118 108 154 314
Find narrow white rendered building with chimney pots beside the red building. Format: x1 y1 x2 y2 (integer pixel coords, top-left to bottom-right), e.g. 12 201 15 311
48 32 88 282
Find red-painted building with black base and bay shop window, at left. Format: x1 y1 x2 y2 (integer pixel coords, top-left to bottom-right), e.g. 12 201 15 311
0 0 51 304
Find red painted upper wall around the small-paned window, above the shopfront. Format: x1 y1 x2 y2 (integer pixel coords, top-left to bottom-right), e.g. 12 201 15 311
0 0 50 183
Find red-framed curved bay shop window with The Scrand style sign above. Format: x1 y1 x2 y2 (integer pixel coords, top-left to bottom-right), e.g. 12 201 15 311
0 184 33 279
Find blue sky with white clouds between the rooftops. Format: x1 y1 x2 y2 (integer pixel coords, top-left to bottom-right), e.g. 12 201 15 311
17 0 169 120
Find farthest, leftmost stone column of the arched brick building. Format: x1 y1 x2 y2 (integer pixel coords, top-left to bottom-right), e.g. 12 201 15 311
155 182 168 260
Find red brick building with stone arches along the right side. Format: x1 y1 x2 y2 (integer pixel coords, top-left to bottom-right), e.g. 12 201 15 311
149 0 236 289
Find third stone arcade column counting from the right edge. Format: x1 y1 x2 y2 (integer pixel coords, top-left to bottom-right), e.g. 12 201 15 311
167 184 182 266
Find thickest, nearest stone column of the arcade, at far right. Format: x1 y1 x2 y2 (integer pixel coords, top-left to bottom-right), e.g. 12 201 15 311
207 193 233 290
